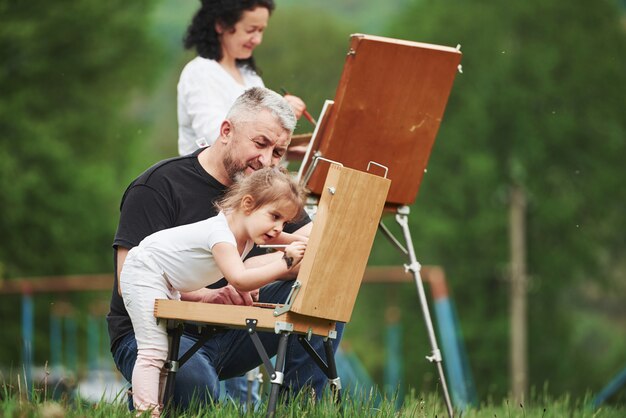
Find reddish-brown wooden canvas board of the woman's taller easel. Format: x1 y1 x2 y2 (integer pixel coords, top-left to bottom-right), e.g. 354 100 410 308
300 34 461 205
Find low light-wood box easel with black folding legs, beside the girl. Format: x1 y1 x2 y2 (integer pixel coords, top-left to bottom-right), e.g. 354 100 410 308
154 164 391 416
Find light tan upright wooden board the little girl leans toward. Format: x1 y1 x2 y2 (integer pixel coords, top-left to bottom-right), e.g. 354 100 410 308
291 164 391 322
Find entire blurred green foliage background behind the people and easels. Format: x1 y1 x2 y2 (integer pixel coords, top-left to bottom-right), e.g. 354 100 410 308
0 0 626 399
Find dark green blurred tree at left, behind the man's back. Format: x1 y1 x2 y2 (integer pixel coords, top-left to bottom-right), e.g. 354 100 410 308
0 0 159 277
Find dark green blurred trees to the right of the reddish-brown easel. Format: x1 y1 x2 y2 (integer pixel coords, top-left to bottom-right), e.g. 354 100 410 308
380 0 626 396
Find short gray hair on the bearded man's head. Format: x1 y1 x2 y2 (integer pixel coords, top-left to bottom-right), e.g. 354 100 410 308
226 87 296 134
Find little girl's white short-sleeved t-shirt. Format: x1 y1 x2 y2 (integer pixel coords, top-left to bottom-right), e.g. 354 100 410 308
131 212 254 292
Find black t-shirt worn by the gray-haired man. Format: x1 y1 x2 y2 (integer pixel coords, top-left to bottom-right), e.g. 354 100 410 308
107 150 310 350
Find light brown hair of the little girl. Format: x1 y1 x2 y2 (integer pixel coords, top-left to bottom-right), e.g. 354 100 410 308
215 167 306 219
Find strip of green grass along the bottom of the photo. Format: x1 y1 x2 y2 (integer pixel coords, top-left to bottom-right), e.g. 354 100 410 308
0 382 626 418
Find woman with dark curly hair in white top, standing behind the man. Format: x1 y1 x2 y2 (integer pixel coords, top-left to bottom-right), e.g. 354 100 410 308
178 0 306 155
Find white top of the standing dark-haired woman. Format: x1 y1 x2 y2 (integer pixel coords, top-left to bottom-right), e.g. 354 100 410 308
178 57 264 155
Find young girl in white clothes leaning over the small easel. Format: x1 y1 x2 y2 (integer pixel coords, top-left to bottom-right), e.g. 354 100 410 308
120 168 307 416
